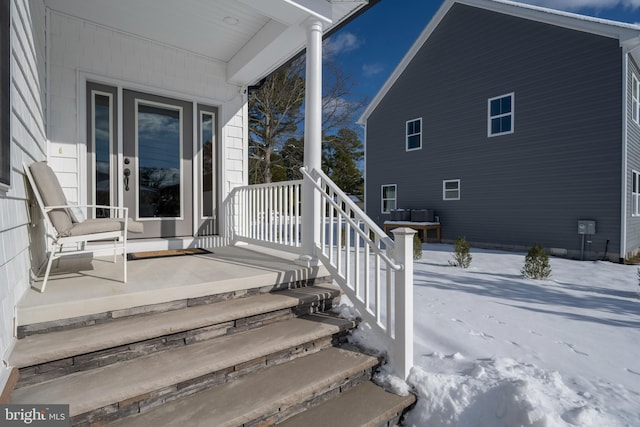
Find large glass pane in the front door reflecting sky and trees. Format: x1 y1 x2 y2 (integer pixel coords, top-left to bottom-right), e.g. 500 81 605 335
137 104 181 218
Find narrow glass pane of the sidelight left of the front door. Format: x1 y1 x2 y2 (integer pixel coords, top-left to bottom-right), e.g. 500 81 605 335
93 94 112 218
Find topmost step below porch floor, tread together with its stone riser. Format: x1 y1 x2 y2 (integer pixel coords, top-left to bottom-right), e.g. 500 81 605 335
8 284 340 387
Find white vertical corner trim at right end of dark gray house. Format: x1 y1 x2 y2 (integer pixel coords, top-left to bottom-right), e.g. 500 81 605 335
619 41 640 262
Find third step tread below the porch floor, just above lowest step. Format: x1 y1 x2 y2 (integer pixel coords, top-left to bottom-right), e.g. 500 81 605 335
107 347 382 427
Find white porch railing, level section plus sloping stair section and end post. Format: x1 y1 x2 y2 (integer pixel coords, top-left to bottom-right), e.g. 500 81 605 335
231 168 415 379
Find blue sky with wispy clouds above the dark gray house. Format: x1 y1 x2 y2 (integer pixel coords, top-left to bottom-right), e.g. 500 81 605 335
325 0 640 117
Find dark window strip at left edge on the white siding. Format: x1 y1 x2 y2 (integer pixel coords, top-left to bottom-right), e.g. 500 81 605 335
0 0 12 187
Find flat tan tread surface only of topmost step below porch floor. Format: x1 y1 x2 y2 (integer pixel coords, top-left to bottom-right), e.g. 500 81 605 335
8 286 338 368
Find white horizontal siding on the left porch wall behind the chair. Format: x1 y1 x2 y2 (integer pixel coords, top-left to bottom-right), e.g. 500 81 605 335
0 0 46 390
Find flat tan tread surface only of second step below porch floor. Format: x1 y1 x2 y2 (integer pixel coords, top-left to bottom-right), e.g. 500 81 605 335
12 314 353 416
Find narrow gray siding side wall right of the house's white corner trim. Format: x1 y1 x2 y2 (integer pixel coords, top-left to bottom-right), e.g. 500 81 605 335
626 58 640 252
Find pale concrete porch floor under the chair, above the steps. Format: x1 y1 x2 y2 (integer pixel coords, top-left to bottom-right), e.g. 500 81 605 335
17 245 329 326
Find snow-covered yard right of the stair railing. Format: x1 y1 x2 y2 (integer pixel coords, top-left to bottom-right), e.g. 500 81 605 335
342 244 640 427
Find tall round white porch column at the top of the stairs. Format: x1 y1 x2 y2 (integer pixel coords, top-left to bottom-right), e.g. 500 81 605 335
298 18 322 266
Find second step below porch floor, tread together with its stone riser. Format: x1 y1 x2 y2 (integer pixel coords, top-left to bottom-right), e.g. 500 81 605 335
11 314 358 425
